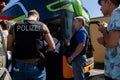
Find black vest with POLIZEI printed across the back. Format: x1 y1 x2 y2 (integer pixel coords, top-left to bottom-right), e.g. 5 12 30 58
14 20 44 59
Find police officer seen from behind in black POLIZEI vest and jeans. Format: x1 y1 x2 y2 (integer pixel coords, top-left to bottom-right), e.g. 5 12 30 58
7 10 55 80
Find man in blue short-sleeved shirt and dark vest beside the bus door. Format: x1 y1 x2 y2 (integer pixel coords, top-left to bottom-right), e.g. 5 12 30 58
68 16 88 80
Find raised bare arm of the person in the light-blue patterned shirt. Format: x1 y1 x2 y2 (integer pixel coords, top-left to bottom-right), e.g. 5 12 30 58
99 23 120 48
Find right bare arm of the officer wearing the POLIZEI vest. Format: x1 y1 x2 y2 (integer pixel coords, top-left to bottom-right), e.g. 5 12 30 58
44 25 55 51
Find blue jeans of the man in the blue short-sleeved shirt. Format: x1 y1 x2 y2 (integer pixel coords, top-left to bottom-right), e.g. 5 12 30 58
72 55 86 80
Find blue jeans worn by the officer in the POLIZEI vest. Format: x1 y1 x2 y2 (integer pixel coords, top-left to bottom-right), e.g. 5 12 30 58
12 62 46 80
